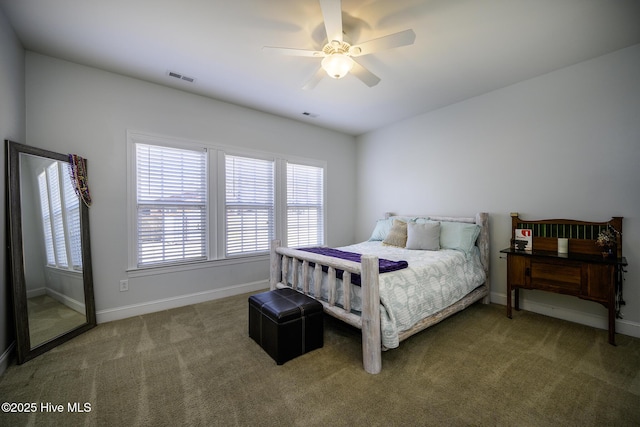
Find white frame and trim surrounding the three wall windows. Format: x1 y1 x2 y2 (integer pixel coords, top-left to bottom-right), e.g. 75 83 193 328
127 130 328 274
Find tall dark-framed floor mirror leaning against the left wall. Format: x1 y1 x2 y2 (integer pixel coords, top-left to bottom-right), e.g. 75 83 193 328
5 141 96 364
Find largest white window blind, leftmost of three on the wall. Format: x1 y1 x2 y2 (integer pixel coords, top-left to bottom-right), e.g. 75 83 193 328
136 144 207 266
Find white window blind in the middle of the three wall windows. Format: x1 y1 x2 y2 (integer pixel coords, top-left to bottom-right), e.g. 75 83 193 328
225 155 275 255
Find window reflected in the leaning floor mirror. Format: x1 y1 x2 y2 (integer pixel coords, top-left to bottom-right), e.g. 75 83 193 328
38 162 82 270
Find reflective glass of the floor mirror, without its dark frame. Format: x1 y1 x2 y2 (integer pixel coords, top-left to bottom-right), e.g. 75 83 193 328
20 153 87 347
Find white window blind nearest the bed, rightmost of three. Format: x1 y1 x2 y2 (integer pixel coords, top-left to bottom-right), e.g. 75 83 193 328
287 163 324 247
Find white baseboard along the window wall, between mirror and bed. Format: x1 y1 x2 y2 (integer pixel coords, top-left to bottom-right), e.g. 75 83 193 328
96 280 269 323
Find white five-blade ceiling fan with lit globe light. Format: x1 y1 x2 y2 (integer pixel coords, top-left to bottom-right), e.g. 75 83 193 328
262 0 416 89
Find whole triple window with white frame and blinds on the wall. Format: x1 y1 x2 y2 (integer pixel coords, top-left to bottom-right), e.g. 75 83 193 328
128 132 325 270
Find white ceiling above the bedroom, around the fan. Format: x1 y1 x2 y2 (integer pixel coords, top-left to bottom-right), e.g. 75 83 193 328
0 0 640 135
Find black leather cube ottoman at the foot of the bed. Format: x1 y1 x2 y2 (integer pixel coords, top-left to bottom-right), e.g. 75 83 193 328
249 288 324 365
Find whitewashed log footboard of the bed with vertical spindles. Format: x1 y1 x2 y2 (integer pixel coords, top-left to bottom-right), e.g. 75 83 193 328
269 240 382 374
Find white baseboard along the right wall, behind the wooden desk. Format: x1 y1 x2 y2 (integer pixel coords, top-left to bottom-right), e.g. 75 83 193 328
491 292 640 338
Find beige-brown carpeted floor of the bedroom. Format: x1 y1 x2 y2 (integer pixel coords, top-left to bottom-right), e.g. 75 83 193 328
0 295 640 426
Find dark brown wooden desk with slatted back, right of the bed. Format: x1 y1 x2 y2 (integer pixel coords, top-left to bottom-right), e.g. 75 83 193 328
500 213 627 345
